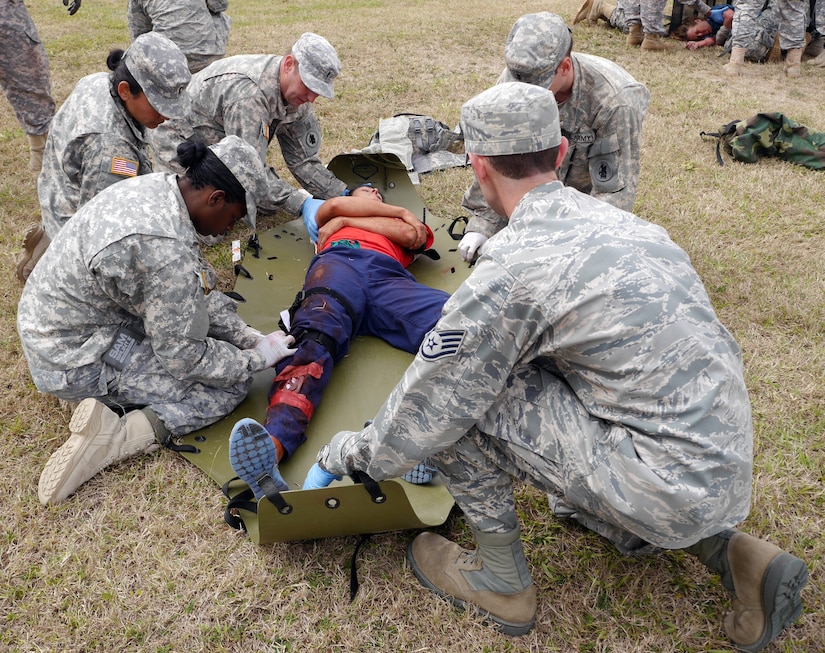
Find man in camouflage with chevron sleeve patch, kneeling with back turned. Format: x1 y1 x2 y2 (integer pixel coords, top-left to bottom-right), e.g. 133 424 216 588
308 82 808 651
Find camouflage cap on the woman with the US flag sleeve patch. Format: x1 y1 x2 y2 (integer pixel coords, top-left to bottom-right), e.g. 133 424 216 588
123 32 192 118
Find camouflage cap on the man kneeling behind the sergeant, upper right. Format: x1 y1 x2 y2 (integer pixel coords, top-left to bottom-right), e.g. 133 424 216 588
504 11 573 88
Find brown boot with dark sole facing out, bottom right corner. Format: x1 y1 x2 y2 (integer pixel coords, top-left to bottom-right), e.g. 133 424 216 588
685 530 808 653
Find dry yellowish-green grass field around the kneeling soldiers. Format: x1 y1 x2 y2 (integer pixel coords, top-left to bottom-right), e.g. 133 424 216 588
0 0 825 653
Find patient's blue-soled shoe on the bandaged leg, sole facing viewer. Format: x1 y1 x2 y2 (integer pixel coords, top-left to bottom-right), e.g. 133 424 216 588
229 417 289 501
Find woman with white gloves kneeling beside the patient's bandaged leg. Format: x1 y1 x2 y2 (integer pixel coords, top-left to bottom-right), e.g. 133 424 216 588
17 136 292 504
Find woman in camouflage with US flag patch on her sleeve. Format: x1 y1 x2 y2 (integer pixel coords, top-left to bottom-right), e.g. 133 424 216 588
17 32 192 281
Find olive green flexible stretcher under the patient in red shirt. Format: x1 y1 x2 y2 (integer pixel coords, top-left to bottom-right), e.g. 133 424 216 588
179 154 469 544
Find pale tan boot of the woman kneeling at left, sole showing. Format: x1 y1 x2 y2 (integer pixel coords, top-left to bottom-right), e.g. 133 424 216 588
37 399 160 505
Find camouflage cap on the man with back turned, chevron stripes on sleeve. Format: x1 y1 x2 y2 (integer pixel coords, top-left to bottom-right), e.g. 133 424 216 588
461 82 561 156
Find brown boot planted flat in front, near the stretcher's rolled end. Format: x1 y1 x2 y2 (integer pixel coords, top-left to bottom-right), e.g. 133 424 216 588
407 529 536 635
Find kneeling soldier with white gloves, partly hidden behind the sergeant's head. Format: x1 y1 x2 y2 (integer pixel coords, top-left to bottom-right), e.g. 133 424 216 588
458 12 650 261
